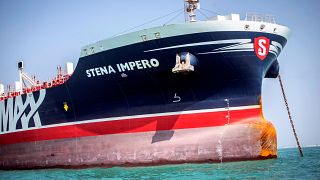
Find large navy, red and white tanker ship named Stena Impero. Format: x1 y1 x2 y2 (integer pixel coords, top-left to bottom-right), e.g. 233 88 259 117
0 0 290 169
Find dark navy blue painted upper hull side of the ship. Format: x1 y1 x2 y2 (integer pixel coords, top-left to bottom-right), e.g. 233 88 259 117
35 32 286 125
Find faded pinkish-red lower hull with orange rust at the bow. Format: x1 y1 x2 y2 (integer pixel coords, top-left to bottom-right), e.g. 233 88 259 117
0 118 277 169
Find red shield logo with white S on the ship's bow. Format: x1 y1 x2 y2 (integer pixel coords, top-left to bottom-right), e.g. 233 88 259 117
254 36 270 60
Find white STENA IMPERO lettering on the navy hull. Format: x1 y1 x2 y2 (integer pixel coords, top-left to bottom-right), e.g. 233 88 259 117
86 58 159 78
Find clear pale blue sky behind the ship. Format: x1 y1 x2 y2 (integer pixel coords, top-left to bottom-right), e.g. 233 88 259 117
0 0 320 147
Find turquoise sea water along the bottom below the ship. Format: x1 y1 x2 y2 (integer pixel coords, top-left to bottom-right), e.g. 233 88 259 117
0 147 320 180
